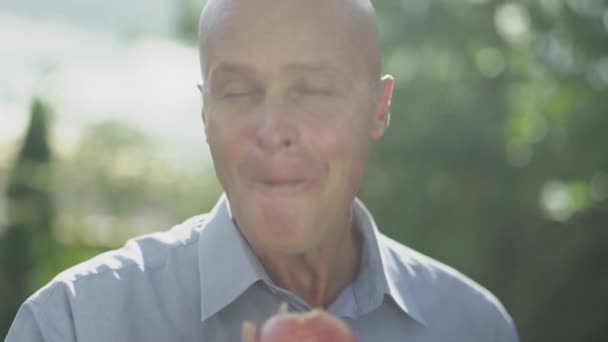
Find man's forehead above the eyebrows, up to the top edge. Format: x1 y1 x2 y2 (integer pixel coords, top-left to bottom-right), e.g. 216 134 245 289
201 0 356 76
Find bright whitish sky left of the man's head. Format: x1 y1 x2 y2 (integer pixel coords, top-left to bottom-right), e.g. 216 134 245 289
0 0 204 159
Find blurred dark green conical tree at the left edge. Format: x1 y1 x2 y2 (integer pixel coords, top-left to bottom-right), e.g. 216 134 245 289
0 98 55 335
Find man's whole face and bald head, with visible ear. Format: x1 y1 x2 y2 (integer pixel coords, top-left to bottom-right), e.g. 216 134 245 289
202 1 392 253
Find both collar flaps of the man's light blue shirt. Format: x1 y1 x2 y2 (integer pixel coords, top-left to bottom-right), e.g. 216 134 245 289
198 194 426 325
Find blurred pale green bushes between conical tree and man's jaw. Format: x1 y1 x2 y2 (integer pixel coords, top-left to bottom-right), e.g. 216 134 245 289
56 120 220 247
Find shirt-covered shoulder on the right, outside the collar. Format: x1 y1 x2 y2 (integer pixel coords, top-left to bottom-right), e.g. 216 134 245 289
379 234 517 341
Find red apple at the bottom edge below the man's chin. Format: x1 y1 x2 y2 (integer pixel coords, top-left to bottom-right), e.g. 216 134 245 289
259 309 357 342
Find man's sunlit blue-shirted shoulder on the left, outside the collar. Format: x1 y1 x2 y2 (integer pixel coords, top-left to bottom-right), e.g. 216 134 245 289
9 215 214 341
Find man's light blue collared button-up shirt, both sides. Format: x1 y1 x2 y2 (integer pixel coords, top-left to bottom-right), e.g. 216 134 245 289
6 196 518 342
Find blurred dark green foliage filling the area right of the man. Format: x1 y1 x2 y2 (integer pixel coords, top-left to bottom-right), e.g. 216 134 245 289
361 0 608 341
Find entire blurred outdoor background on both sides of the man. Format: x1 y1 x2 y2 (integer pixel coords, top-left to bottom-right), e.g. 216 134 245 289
0 0 608 342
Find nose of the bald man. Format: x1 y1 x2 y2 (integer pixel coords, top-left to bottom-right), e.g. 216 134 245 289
256 101 298 153
